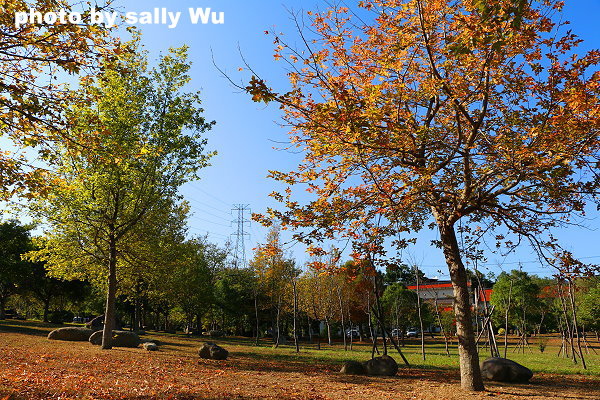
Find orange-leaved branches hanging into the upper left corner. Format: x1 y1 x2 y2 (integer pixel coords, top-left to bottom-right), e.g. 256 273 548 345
0 0 118 198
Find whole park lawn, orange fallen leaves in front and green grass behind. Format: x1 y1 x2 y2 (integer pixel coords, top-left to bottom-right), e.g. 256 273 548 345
0 320 600 400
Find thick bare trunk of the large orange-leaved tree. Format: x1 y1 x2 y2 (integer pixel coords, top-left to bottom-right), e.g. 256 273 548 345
436 219 485 391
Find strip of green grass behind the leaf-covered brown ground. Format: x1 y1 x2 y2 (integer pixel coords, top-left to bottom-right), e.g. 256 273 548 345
0 320 600 376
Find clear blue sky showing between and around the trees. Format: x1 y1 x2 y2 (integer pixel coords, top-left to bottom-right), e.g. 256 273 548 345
7 0 600 277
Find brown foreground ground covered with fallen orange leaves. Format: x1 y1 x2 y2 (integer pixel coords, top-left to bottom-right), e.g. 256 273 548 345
0 332 600 400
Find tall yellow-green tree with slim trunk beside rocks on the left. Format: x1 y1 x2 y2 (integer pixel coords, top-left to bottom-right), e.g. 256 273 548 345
29 34 212 349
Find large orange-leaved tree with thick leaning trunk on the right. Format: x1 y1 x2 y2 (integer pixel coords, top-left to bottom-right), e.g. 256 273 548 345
245 0 600 390
